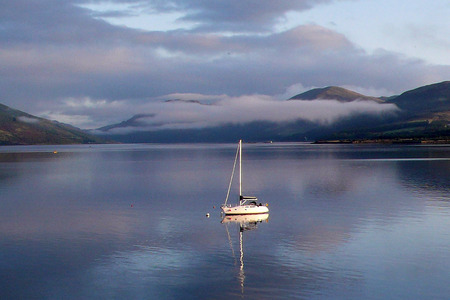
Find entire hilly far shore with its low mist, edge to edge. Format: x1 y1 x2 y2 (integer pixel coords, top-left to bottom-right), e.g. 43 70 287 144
0 81 450 145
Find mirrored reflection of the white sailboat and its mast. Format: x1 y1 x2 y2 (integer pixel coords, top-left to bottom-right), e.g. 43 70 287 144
221 214 269 293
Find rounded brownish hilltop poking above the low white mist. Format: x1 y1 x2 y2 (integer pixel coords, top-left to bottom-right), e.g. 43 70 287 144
289 86 383 102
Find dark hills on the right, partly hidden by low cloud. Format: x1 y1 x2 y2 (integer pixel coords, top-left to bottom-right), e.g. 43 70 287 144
286 81 450 143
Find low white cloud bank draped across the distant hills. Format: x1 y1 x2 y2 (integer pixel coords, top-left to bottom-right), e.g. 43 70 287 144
90 95 398 133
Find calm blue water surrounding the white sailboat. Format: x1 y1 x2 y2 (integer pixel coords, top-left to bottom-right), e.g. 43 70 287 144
0 144 450 299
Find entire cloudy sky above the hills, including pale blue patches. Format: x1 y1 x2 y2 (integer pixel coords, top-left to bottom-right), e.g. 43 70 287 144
0 0 450 128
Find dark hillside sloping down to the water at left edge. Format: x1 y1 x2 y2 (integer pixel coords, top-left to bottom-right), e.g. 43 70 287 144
0 104 105 145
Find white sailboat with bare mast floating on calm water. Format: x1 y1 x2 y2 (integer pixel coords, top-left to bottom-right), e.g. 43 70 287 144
221 140 269 215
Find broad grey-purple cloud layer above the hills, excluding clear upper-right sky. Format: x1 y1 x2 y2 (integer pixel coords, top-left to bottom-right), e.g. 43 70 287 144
0 0 450 128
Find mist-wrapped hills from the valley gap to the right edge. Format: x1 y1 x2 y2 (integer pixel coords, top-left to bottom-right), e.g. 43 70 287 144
95 81 450 142
